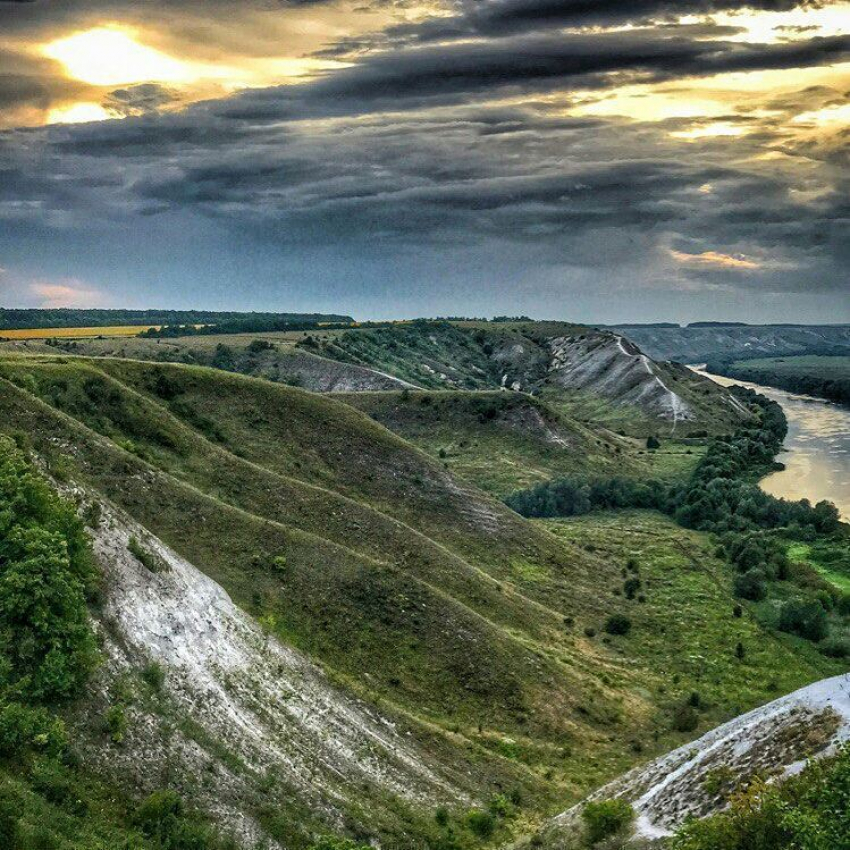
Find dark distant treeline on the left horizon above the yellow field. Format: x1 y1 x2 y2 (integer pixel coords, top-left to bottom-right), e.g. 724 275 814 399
0 307 354 331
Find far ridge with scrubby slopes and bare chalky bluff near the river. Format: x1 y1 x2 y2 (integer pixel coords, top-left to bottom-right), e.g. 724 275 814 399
4 320 743 439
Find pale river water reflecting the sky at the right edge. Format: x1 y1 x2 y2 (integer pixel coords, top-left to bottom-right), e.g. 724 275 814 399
697 370 850 521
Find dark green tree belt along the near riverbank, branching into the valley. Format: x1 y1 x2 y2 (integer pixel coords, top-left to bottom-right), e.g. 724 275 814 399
505 387 850 658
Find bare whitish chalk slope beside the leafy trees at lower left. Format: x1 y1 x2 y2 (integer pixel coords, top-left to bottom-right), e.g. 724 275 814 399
88 506 467 835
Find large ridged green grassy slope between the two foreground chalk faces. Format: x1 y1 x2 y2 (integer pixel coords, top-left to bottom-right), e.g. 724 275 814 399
0 356 839 848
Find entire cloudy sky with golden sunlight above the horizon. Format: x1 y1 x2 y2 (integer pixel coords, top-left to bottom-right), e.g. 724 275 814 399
0 0 850 322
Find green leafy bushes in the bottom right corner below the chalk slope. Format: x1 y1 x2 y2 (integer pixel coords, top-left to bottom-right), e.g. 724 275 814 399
670 746 850 850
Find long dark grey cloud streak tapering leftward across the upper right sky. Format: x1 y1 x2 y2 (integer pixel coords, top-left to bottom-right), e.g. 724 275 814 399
211 30 850 121
